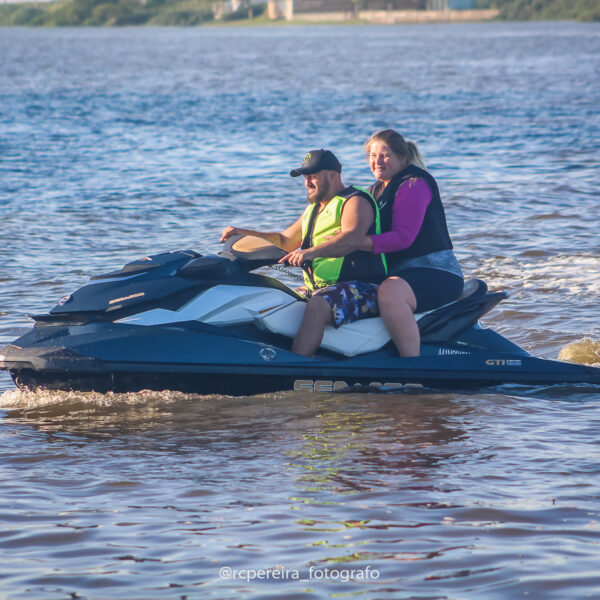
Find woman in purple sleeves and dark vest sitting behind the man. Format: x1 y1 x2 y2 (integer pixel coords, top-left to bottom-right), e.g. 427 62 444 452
359 129 463 356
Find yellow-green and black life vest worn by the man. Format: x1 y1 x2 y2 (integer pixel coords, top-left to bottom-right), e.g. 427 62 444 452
302 186 387 290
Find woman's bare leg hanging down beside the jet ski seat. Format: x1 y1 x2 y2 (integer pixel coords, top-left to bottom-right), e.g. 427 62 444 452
377 277 421 356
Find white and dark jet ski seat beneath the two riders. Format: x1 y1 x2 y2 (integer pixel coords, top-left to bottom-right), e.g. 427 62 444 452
255 279 506 356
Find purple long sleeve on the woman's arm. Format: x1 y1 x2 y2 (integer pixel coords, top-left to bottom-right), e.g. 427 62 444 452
371 178 432 254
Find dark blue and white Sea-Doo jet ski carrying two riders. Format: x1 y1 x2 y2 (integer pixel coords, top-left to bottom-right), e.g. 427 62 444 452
0 236 600 395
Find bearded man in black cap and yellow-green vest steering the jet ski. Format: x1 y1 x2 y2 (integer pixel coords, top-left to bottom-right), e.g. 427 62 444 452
221 150 386 356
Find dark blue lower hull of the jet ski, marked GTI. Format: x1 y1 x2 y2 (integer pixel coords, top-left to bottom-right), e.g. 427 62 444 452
0 323 600 395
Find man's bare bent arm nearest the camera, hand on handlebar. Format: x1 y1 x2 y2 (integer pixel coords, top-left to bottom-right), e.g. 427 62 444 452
279 195 375 267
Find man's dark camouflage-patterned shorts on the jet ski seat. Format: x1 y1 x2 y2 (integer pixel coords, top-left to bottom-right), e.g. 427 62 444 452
313 281 379 329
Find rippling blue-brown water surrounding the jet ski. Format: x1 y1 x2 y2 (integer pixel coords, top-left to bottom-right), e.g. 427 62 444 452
0 23 600 600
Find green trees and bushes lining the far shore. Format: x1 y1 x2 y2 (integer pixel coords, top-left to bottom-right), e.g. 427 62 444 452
0 0 600 27
